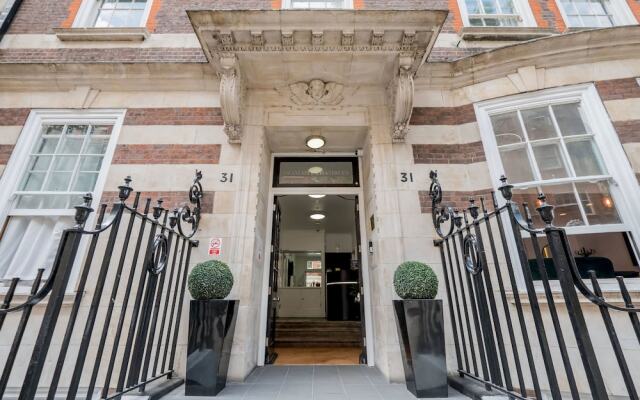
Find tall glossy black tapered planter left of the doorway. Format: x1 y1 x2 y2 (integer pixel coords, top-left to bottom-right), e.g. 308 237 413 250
185 300 239 396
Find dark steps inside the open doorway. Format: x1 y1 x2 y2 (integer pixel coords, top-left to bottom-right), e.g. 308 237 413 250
276 318 361 347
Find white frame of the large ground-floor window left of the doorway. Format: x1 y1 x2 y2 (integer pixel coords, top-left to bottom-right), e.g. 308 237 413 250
0 109 125 294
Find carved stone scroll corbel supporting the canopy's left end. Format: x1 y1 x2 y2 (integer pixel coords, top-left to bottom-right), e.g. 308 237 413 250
220 54 244 143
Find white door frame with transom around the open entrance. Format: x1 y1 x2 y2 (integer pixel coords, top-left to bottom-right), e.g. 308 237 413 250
258 152 375 367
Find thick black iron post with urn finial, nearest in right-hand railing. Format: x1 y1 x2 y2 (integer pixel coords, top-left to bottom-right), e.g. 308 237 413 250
537 196 609 400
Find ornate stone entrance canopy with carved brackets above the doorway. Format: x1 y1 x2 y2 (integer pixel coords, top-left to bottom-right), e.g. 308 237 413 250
188 10 447 142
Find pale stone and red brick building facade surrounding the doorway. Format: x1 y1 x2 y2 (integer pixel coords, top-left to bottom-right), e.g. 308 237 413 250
0 0 640 394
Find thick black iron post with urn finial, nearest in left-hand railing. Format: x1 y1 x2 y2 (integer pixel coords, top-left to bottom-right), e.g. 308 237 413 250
18 194 93 400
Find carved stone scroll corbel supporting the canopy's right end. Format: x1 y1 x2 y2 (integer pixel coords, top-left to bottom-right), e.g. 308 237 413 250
391 56 413 142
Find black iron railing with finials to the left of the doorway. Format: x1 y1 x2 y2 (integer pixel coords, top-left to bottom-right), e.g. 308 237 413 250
0 171 203 400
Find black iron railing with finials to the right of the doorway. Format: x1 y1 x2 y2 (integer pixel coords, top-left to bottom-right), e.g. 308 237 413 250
430 171 640 400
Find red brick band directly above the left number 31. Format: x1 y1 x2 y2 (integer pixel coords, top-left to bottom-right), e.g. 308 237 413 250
113 144 220 164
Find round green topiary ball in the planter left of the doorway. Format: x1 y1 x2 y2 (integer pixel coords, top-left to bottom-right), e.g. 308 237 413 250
187 260 233 300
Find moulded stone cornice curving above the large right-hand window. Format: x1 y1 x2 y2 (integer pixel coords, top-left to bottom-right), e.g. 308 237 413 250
415 25 640 89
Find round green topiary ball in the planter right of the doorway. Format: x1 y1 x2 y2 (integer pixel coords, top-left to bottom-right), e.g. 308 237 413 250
393 261 438 299
